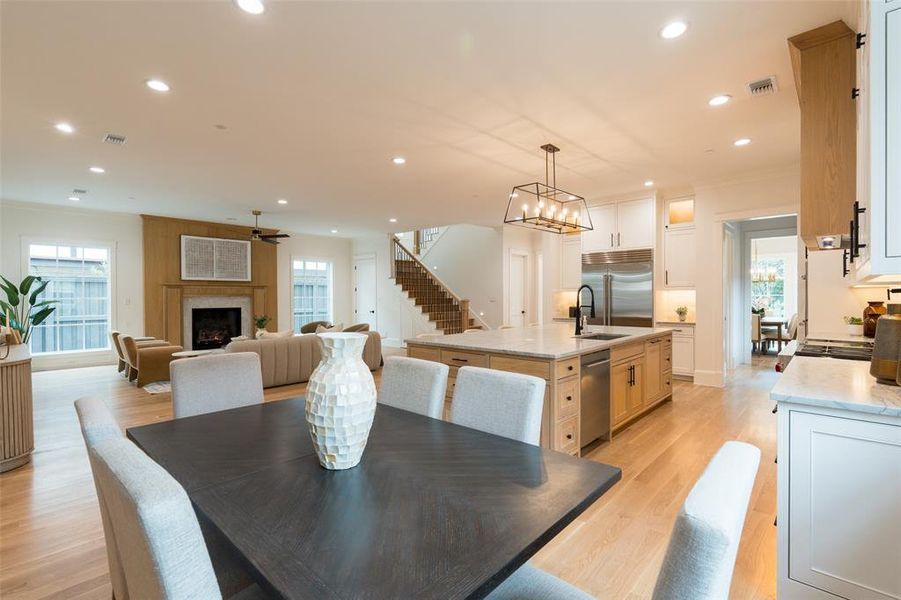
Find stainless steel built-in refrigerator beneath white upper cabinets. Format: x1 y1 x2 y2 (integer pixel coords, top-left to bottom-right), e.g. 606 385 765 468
581 250 654 327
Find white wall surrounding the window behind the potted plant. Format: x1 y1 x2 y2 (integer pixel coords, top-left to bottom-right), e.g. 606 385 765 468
0 201 144 370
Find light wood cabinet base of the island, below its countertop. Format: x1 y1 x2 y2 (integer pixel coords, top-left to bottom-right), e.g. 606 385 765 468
407 325 672 456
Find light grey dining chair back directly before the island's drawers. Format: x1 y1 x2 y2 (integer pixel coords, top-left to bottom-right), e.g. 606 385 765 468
450 367 545 446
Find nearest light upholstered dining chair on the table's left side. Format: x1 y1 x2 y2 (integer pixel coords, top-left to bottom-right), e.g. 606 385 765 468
89 437 266 600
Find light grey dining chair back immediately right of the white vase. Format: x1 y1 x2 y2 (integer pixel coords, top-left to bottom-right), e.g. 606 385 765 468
378 356 450 419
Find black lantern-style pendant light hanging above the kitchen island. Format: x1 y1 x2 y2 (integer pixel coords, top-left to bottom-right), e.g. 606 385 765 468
504 144 594 234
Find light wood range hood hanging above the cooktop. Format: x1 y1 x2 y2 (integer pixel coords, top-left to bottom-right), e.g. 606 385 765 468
788 21 857 250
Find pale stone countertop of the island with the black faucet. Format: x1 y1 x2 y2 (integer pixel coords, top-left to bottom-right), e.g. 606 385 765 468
406 323 672 359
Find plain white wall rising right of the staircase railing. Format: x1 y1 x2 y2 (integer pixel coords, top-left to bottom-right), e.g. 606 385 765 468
412 225 504 328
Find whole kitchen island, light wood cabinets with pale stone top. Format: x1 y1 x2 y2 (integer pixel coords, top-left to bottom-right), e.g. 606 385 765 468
406 323 672 456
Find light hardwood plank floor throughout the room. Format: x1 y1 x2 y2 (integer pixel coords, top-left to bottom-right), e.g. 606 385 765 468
0 356 778 600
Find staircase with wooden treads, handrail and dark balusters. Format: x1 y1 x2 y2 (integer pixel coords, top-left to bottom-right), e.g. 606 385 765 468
391 237 476 335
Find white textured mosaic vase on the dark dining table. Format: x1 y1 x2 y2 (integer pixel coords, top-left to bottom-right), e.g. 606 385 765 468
306 333 376 470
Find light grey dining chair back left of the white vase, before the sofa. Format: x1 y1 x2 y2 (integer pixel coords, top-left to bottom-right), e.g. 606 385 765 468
169 352 263 419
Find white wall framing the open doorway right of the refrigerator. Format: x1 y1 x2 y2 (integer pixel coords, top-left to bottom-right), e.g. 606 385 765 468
695 169 800 387
